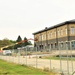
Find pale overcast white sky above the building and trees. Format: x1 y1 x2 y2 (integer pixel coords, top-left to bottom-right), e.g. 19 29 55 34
0 0 75 40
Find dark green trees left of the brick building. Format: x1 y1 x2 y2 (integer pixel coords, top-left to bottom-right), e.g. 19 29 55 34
0 35 32 50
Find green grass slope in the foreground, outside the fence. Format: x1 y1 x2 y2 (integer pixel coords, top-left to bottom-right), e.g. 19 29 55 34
0 60 55 75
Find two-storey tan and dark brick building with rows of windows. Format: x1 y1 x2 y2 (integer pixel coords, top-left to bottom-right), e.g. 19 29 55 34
33 20 75 50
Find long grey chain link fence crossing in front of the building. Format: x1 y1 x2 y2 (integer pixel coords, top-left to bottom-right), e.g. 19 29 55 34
0 46 75 75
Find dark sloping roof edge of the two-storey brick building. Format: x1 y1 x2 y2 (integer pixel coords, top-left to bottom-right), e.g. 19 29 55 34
33 19 75 35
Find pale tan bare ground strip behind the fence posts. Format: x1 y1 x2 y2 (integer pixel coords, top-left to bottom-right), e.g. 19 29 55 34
0 55 75 72
